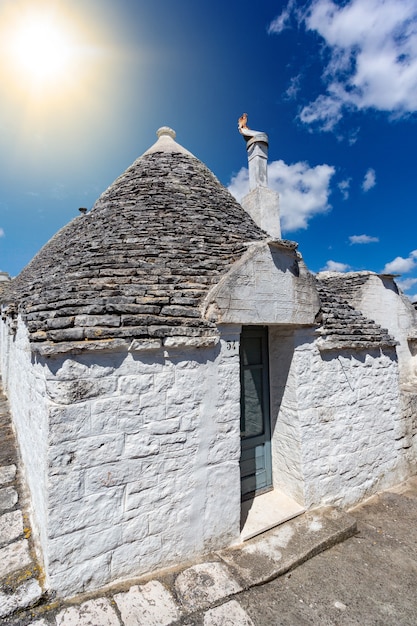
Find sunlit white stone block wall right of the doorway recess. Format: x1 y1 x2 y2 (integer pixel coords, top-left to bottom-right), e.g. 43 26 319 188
293 330 408 507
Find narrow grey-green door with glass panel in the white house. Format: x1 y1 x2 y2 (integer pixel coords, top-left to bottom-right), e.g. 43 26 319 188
240 326 272 499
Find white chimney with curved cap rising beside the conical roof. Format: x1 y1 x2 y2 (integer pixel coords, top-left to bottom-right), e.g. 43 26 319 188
238 113 281 239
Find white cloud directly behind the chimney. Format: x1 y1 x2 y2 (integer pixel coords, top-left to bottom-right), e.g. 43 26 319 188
229 160 335 231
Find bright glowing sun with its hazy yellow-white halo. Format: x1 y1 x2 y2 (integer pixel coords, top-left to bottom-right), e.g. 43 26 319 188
0 0 110 133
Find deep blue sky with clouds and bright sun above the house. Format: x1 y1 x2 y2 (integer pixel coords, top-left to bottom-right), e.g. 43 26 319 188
0 0 417 299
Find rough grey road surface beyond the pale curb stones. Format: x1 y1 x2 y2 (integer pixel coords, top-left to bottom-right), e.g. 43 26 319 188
237 477 417 626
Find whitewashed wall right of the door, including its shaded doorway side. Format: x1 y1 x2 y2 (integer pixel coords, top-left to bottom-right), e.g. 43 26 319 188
270 329 409 507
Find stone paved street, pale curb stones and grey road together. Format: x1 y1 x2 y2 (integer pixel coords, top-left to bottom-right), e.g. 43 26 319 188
3 478 417 626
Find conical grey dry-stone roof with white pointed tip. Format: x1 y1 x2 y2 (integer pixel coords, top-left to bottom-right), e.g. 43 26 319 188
3 128 267 354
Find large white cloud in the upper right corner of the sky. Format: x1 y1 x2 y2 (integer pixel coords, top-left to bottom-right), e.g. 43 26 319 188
268 0 417 131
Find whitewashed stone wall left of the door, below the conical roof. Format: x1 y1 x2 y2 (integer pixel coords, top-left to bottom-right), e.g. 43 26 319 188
0 327 240 594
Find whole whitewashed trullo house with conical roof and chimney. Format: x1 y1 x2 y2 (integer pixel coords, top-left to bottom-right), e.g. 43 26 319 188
1 123 417 595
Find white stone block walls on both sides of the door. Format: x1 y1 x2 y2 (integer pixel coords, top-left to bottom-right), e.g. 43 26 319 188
1 312 416 595
